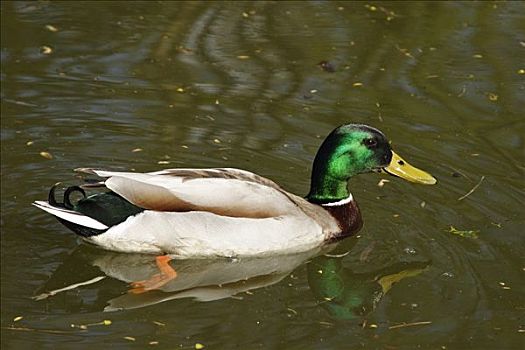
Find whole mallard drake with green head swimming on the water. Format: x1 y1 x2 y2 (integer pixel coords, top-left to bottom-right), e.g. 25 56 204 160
34 124 436 257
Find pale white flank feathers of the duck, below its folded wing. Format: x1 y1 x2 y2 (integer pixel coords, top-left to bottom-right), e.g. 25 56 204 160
86 210 325 258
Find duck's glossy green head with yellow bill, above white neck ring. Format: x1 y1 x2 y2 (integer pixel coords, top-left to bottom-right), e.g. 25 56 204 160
307 124 436 203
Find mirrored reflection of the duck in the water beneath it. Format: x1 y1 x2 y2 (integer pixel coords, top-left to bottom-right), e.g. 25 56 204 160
35 238 429 319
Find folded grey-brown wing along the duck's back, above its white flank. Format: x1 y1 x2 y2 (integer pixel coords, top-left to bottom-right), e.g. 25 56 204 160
76 168 300 218
